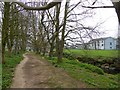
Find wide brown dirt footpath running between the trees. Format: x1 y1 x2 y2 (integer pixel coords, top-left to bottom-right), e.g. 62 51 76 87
11 54 85 88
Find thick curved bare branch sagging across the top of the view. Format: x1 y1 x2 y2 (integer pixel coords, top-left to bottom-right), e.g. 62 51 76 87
13 0 62 10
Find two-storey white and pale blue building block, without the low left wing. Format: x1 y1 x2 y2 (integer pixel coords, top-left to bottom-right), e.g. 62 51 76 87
88 37 118 50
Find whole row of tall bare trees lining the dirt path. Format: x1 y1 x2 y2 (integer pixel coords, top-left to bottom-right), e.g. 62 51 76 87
1 1 117 63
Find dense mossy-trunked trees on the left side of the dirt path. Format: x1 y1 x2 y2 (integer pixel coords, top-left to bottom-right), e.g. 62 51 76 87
1 2 28 63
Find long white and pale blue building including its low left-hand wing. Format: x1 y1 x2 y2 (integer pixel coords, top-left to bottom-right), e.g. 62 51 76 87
77 37 120 50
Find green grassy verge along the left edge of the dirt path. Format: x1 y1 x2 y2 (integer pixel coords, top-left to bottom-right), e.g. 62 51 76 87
2 53 23 88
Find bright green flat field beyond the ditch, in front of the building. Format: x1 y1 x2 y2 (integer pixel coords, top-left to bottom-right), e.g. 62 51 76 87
65 49 118 57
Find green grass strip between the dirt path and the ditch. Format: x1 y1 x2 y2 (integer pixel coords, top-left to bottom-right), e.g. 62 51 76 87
45 58 118 88
